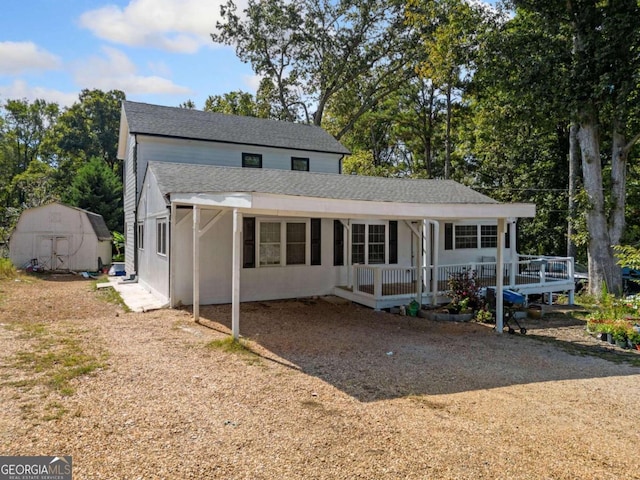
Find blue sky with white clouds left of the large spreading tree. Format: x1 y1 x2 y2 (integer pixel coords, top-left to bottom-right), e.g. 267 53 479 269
0 0 259 109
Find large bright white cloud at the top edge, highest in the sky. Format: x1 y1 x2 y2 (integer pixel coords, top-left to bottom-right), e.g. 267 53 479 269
80 0 245 53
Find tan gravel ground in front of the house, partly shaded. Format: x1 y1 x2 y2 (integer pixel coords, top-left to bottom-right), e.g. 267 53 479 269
0 276 640 479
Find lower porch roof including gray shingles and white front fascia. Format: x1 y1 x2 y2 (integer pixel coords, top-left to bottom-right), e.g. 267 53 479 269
149 162 535 218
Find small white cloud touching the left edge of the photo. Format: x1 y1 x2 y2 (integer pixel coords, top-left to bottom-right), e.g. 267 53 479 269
0 42 61 75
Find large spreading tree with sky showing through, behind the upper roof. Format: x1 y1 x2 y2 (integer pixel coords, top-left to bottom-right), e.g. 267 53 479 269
211 0 407 139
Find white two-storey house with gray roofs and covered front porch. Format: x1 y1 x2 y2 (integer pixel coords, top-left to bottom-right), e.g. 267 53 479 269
118 101 573 335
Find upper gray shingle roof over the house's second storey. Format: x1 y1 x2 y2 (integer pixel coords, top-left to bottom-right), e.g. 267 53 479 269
122 101 350 155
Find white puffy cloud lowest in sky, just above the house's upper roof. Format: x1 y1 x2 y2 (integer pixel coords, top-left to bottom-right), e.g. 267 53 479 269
73 47 191 96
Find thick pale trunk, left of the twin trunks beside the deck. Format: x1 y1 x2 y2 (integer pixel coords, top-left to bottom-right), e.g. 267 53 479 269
578 121 622 295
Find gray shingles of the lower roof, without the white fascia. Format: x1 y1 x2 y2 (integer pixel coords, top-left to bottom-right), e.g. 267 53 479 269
149 162 499 204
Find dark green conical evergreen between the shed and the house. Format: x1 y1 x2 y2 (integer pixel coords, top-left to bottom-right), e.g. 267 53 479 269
63 157 124 232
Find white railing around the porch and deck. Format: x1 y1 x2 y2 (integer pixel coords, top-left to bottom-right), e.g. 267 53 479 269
353 255 574 299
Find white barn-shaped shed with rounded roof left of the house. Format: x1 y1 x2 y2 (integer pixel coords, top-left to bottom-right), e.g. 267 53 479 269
9 203 111 271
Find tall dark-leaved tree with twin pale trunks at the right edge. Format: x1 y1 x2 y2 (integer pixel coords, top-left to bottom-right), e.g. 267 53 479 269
514 0 640 293
